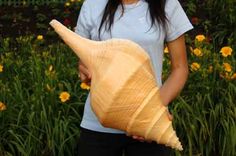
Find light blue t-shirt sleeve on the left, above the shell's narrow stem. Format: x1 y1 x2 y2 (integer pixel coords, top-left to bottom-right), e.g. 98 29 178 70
75 0 92 39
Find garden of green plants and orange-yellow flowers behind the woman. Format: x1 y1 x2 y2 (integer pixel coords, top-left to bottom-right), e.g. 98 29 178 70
0 0 236 156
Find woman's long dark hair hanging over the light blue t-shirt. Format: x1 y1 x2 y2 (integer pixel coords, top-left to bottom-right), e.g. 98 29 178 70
98 0 167 38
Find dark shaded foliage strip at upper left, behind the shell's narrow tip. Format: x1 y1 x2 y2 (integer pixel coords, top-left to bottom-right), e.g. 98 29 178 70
0 0 83 37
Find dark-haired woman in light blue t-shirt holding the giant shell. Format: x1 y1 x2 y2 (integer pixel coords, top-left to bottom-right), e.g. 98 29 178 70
76 0 192 156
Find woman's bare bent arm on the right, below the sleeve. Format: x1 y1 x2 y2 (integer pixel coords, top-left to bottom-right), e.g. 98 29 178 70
160 35 189 106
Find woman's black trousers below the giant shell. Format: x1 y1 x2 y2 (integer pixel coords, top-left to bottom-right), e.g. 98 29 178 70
78 128 171 156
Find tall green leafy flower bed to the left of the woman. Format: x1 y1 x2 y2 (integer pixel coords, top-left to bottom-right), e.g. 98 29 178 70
0 36 87 156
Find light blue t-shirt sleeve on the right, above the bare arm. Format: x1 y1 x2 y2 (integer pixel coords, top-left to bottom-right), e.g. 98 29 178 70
165 0 193 42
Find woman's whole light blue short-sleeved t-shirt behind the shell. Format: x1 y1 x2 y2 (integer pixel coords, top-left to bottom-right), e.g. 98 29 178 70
75 0 193 133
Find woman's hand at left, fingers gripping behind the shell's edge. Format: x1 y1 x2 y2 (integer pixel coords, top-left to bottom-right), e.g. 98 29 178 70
78 61 92 85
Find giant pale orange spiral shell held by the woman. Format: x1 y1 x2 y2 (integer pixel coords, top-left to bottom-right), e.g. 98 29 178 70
50 20 183 150
